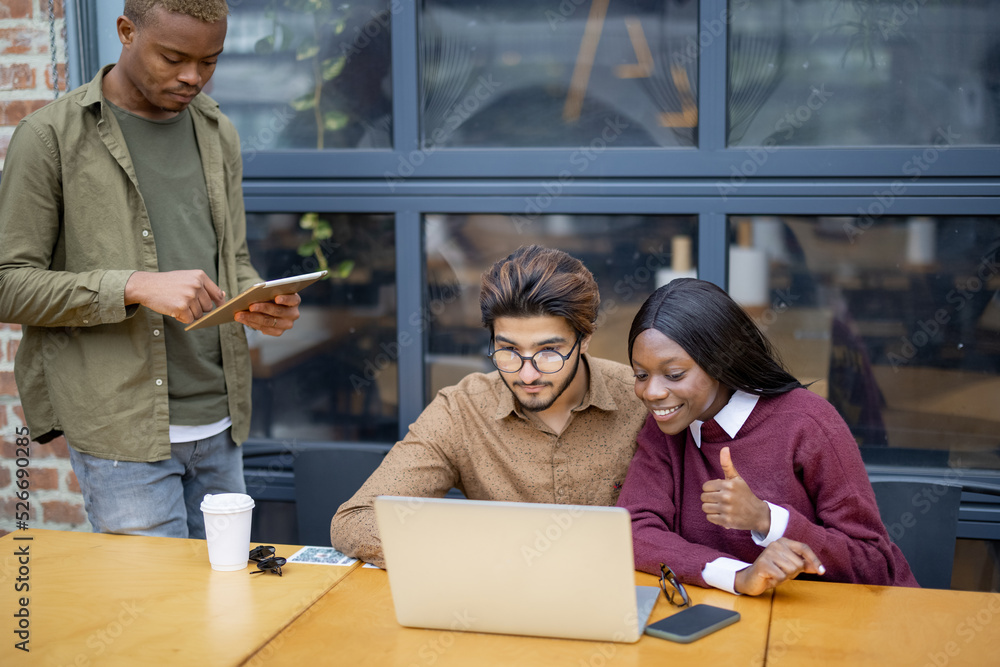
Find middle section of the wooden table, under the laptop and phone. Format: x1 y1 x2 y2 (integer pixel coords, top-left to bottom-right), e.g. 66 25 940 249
248 568 771 667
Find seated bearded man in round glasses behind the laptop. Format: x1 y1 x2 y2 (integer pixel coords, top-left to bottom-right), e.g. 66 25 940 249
330 246 645 566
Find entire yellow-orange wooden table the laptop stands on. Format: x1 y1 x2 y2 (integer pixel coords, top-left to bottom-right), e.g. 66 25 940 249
7 530 1000 667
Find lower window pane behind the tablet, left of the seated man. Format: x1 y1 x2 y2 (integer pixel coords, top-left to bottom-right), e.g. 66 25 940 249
247 213 399 442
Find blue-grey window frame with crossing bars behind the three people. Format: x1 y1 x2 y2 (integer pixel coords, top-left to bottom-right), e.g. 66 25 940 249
78 0 1000 539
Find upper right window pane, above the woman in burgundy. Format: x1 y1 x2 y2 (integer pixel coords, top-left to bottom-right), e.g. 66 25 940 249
728 0 1000 146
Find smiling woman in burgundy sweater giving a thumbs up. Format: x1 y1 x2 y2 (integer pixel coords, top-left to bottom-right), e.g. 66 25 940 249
618 278 917 595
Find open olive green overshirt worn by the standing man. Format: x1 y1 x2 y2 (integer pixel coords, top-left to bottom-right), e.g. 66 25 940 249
0 66 260 461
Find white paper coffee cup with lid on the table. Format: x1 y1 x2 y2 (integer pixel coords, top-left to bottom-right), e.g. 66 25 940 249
201 493 254 572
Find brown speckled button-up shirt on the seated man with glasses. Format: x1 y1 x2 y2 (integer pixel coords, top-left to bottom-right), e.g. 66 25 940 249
330 355 646 566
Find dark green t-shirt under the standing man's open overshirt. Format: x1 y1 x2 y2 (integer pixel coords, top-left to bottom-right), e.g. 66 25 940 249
109 103 229 426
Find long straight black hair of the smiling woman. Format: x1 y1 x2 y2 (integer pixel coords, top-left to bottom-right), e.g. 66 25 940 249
628 278 803 396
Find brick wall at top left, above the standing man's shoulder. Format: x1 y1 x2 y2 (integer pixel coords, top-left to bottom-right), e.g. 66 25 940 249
0 0 66 169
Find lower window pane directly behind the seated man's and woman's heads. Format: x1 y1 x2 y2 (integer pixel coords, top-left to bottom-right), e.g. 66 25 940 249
424 215 698 400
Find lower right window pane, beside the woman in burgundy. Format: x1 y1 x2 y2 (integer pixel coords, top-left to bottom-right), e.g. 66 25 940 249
730 216 1000 470
